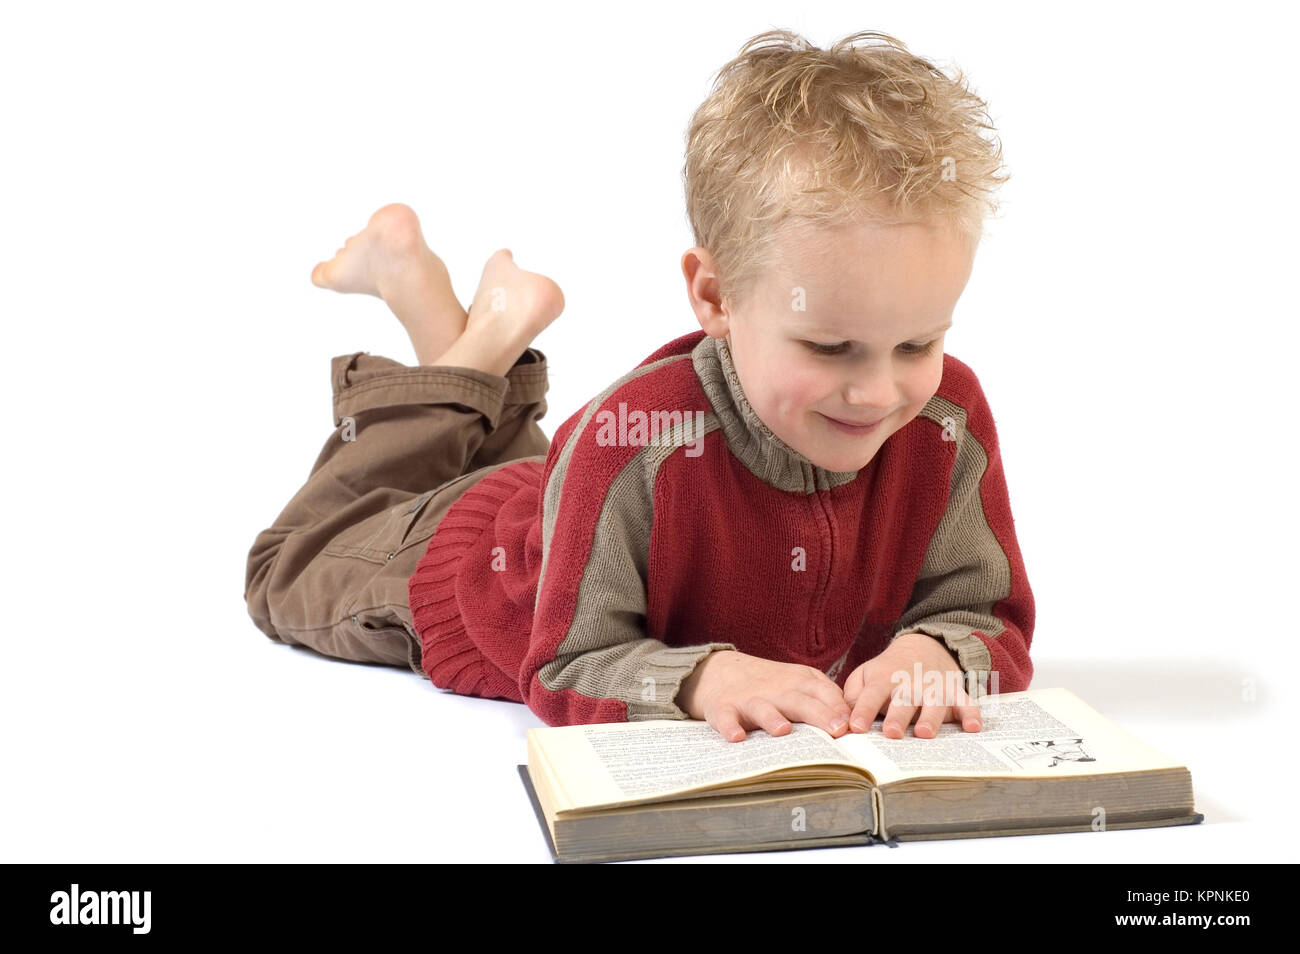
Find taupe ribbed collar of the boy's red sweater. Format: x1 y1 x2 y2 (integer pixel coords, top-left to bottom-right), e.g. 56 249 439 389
690 334 858 494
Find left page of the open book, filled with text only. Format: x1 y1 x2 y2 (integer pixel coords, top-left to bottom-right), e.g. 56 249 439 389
528 719 858 811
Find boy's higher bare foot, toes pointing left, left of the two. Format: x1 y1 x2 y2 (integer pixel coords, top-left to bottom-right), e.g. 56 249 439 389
312 203 467 364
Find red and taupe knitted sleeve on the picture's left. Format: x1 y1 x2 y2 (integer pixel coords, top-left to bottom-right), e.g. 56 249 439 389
519 408 736 725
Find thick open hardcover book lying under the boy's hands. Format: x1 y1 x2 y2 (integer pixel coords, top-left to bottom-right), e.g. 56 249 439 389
519 689 1204 862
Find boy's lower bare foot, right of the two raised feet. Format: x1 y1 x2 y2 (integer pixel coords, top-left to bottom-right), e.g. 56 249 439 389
436 248 564 376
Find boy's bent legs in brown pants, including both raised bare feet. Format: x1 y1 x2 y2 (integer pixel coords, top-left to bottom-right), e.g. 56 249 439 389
244 205 563 673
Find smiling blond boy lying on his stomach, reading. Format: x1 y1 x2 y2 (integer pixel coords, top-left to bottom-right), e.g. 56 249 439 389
246 31 1034 741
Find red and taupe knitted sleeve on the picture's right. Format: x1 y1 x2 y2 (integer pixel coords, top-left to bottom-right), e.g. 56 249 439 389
891 378 1035 694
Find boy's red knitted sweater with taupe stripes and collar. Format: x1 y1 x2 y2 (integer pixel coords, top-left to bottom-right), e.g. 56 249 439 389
410 331 1034 725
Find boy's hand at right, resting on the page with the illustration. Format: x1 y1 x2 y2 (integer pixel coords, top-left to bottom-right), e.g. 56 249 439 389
844 633 983 738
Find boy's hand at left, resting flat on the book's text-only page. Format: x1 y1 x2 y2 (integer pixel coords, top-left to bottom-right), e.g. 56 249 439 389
677 650 849 742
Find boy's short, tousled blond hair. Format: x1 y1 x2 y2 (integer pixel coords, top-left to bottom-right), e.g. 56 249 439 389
681 30 1010 305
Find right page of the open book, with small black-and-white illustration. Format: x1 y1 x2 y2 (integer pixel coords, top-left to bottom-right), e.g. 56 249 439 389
836 689 1180 785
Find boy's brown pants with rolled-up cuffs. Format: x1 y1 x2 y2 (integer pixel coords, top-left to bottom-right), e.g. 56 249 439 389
244 348 550 677
